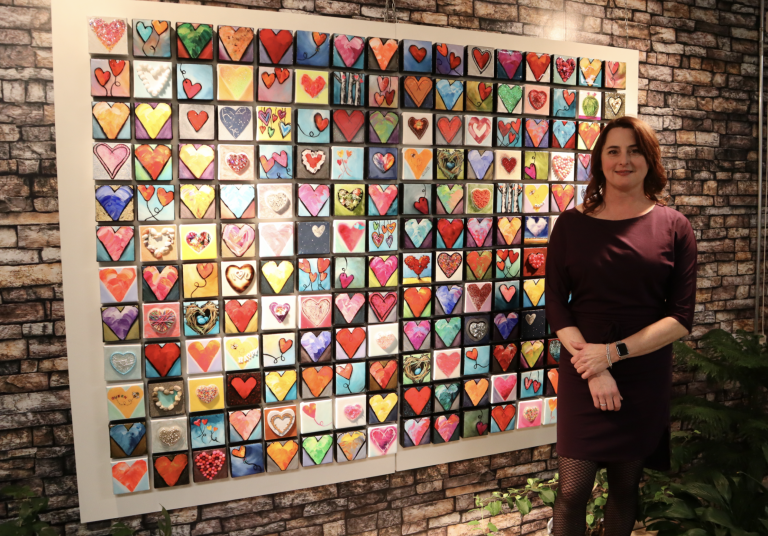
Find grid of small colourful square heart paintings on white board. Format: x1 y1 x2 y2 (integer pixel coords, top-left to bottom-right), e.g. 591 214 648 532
87 18 626 494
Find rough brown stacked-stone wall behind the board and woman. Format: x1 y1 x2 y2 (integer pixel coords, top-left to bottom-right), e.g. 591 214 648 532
0 0 759 536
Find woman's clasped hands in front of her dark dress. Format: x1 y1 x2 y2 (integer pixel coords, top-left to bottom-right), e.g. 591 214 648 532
571 341 623 411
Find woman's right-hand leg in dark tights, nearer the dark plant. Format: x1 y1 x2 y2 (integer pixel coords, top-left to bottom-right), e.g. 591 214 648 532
605 460 643 536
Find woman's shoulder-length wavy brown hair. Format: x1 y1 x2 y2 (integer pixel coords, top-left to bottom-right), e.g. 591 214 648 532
583 117 667 214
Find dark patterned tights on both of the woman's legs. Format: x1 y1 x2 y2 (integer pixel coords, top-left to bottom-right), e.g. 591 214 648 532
554 456 643 536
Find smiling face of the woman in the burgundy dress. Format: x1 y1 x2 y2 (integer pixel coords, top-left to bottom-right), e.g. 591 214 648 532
601 128 648 192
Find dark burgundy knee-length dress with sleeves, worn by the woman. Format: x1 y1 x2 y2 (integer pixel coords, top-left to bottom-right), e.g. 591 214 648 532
546 205 696 470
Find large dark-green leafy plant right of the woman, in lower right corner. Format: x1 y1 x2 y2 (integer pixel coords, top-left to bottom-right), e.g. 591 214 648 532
638 330 768 536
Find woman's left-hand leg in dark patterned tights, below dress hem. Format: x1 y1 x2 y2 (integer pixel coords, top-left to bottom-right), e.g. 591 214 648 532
554 456 597 536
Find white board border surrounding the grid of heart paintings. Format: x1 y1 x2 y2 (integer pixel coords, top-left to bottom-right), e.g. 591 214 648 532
52 0 639 523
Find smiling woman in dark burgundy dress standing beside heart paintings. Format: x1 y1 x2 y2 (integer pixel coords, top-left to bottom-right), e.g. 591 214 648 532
546 117 696 536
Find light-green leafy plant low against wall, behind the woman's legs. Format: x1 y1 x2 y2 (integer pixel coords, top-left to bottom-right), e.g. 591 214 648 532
467 469 608 534
